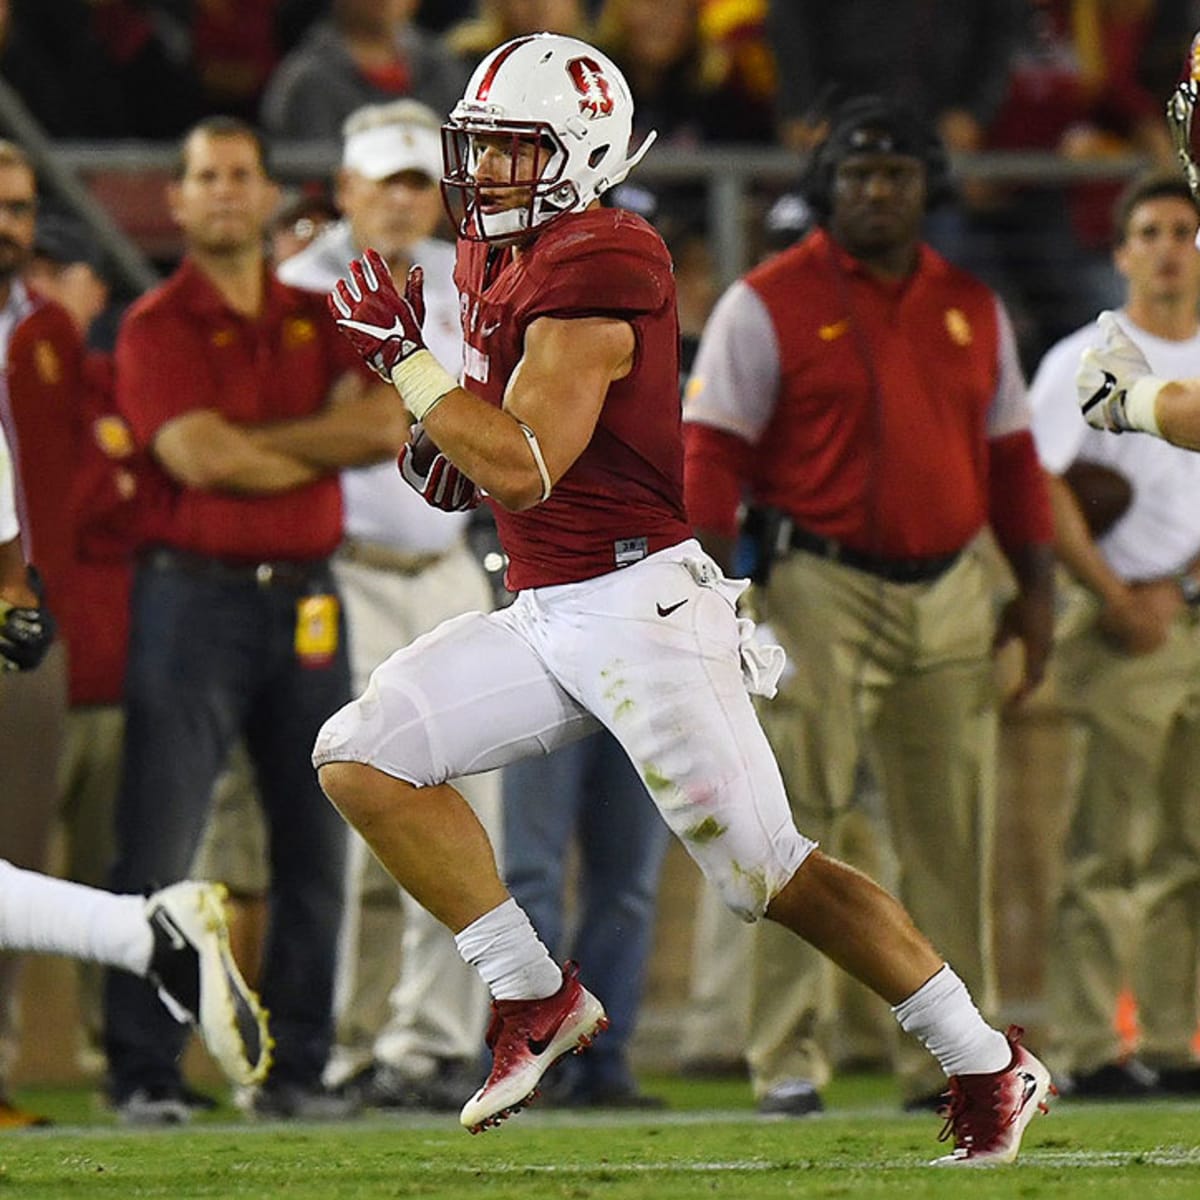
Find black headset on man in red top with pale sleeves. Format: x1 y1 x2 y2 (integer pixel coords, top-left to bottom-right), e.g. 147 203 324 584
800 96 954 223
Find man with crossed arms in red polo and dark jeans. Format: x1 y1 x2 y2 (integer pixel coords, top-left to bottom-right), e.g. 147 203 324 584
106 118 406 1124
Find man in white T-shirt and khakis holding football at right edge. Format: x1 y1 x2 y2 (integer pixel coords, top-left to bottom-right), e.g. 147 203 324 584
1030 175 1200 1097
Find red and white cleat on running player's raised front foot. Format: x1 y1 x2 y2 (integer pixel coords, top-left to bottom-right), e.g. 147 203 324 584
458 962 608 1133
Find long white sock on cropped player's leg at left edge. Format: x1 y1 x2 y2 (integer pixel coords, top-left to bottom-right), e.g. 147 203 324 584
0 859 154 976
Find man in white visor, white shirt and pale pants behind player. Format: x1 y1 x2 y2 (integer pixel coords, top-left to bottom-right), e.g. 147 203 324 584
278 100 499 1109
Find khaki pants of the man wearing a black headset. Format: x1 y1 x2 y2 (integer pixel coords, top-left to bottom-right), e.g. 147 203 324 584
748 550 997 1099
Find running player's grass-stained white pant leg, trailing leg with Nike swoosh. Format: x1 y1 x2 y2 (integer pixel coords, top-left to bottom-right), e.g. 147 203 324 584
556 562 812 917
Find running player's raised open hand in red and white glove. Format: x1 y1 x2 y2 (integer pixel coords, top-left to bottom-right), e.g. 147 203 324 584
329 250 426 383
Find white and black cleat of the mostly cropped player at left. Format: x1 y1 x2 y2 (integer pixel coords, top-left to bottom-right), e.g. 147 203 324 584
146 882 274 1084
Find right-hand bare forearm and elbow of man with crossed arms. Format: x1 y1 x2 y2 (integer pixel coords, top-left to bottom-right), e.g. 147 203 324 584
246 372 410 473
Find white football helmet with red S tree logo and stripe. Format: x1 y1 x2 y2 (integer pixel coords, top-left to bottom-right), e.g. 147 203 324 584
442 34 655 242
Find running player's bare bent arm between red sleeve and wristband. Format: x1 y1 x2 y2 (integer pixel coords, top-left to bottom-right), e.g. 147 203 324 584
425 317 635 511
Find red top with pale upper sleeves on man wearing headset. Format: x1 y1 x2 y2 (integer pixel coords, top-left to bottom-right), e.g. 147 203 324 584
685 230 1045 558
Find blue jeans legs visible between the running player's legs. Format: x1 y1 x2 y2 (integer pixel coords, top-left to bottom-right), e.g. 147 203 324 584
504 732 671 1097
